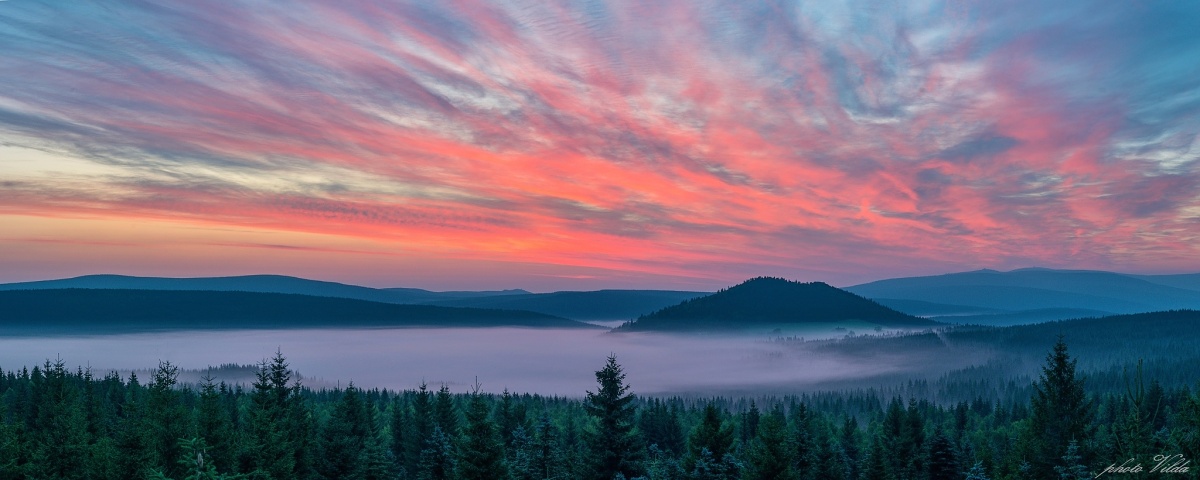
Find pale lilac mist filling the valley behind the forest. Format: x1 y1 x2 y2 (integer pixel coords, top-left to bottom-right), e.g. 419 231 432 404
0 328 986 396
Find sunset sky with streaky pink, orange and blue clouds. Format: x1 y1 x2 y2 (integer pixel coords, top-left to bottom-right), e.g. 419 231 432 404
0 0 1200 292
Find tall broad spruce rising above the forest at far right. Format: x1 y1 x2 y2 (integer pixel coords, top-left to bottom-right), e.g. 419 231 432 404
1027 336 1096 478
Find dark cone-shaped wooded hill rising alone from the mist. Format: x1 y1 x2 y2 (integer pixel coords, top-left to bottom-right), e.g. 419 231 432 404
617 277 936 331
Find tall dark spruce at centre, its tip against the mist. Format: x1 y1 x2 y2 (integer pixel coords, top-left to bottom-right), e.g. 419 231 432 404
583 355 642 480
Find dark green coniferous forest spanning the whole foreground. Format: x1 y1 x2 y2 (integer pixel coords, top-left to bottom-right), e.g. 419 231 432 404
0 338 1200 480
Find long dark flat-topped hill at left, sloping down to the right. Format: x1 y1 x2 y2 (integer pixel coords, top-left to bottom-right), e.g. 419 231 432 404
0 289 598 334
